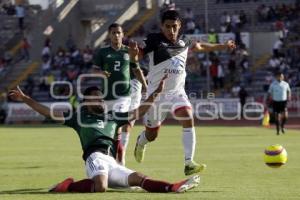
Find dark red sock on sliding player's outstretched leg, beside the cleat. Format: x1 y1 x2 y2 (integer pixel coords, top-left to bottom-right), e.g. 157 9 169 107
141 178 173 193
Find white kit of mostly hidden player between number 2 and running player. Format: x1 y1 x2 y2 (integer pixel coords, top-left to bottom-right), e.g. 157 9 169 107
129 79 142 111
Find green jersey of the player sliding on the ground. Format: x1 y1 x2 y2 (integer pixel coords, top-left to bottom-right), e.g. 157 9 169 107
64 108 129 159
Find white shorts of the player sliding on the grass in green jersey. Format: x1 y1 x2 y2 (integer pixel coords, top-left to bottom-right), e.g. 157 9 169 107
85 152 134 188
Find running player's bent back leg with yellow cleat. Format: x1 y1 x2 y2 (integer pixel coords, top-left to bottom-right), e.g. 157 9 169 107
134 127 159 163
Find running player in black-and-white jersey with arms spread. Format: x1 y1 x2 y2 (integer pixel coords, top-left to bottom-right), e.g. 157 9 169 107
134 10 235 175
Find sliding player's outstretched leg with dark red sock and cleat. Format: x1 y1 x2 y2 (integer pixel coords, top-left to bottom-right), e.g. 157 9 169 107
128 172 200 193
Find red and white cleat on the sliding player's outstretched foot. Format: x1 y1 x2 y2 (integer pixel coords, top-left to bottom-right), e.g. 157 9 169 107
171 175 200 193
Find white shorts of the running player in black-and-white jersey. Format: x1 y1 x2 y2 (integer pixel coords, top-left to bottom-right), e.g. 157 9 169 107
144 91 192 128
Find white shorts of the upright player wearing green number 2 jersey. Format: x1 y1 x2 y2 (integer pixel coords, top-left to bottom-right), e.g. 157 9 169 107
105 97 131 112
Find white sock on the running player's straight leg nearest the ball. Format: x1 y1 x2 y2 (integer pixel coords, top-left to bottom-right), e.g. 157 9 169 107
182 127 196 164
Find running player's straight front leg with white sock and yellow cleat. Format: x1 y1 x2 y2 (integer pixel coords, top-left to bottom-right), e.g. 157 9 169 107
174 107 206 175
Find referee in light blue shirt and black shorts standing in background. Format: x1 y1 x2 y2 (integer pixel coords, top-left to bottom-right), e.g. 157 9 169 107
267 72 291 135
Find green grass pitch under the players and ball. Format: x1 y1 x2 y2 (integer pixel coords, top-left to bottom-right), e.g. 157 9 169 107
0 126 300 200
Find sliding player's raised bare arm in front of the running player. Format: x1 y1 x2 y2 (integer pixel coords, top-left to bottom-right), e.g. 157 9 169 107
129 75 167 121
